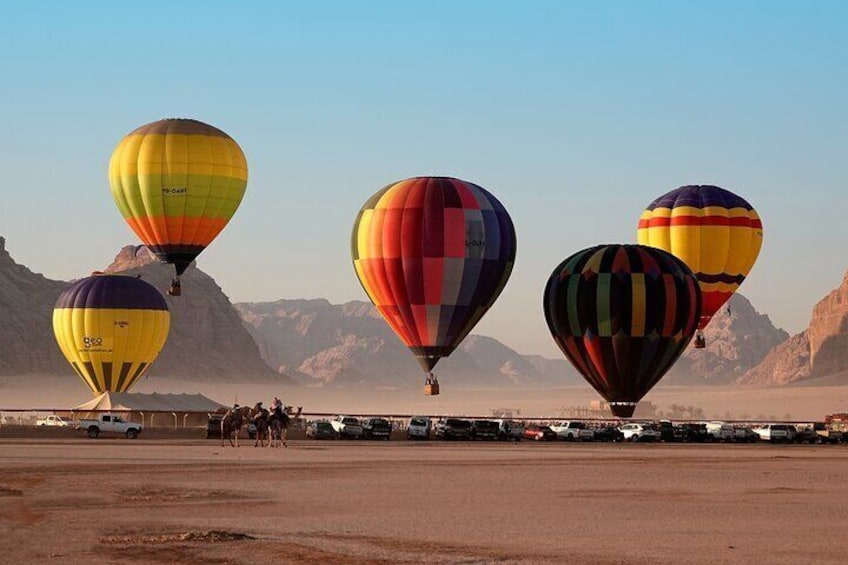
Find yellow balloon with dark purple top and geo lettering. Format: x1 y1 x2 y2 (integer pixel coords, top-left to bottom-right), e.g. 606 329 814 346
53 275 171 394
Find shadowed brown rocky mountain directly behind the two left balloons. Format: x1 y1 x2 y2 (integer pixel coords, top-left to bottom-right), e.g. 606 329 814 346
106 245 294 384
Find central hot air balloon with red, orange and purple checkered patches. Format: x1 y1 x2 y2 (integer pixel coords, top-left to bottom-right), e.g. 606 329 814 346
351 177 516 394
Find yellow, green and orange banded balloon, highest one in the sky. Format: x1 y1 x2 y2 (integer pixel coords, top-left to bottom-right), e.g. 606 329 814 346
109 119 247 296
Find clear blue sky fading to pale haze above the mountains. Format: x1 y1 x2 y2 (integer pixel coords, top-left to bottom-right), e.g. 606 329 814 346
0 0 848 356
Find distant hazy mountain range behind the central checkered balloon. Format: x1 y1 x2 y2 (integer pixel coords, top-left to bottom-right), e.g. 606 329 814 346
235 299 579 388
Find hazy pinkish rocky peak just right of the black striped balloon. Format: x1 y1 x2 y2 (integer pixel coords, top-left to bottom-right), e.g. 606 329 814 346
663 294 789 384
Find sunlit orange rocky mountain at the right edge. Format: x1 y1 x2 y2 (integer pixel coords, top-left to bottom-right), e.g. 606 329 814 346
739 273 848 385
